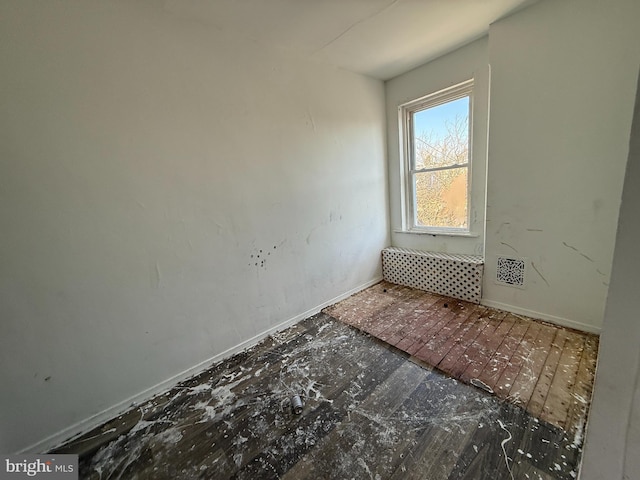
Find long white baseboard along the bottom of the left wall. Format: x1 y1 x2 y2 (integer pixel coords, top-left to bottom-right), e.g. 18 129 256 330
16 276 382 455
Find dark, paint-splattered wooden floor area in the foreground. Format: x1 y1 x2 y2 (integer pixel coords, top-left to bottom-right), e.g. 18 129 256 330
56 314 581 480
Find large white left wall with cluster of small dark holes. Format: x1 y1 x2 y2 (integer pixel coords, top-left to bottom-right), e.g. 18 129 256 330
0 0 389 452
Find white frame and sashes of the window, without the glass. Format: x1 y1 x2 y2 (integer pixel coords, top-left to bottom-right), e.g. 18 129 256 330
398 79 474 236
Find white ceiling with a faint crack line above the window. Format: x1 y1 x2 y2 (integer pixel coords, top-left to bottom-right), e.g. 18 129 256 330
156 0 537 80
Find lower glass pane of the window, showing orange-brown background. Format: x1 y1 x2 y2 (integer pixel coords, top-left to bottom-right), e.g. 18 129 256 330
414 167 469 228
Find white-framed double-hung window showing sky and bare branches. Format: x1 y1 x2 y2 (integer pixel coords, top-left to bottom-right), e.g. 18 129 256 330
400 80 473 233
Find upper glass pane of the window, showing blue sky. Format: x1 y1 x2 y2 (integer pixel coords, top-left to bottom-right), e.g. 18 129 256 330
413 96 469 170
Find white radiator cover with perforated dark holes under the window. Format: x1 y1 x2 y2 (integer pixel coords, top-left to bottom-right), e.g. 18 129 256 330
382 247 484 303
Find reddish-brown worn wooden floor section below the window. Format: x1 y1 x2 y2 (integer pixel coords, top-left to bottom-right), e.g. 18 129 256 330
324 282 598 434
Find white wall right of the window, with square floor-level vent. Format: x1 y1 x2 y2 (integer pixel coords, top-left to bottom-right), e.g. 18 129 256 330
483 0 640 331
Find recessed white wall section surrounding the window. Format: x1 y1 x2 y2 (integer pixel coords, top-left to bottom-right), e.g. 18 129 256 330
385 37 489 255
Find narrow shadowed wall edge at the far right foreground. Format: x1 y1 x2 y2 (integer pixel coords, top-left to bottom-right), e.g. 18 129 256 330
580 69 640 480
